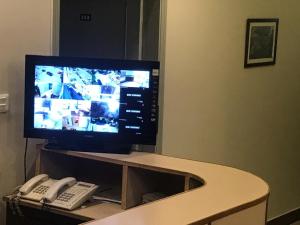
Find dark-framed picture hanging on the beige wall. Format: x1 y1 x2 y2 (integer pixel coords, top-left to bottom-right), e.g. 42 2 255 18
244 18 279 68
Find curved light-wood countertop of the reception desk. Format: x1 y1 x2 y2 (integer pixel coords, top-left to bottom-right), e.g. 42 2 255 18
70 149 269 225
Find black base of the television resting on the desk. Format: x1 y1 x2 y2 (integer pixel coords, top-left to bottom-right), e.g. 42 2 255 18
44 139 132 154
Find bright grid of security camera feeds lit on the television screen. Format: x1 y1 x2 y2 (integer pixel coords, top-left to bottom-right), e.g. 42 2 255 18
34 65 150 133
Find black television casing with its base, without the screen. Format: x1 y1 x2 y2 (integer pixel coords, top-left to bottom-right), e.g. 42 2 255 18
24 55 160 153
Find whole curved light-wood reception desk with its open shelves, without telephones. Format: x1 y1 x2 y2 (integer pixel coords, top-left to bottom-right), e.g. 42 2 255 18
4 145 269 225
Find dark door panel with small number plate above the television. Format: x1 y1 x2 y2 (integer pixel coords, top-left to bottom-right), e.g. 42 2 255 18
59 0 126 58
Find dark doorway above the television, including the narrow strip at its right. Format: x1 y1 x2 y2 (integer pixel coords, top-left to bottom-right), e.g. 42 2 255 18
59 0 159 60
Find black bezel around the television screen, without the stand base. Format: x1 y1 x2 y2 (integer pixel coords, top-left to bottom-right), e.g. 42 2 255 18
24 55 159 150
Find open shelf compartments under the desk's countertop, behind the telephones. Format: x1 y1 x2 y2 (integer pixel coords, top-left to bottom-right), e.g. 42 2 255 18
32 145 203 219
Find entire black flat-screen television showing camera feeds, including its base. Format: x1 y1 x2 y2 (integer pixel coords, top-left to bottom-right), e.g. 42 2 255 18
24 55 159 153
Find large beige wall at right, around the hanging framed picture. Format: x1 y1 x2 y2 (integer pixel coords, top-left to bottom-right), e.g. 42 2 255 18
162 0 300 217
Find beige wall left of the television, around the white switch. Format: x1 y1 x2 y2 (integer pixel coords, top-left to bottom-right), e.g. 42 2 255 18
0 0 52 224
